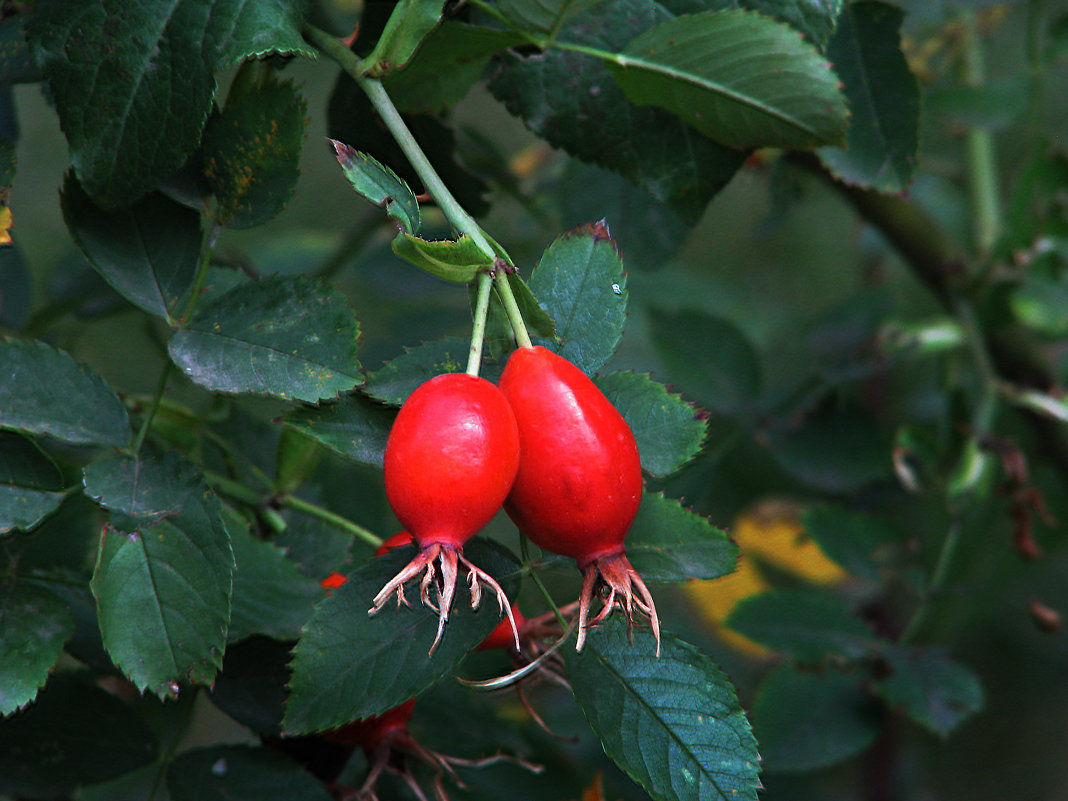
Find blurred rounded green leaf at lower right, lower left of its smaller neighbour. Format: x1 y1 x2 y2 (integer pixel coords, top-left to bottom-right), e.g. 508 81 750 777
752 664 880 773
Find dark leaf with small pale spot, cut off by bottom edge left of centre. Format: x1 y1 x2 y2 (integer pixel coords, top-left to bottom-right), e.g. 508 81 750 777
167 745 333 801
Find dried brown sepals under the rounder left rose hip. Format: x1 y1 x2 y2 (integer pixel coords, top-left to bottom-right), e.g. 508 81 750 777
367 543 519 656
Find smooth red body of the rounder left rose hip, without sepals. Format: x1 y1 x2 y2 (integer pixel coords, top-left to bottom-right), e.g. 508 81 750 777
384 373 519 547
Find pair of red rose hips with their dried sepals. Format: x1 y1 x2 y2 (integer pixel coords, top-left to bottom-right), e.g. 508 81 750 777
372 347 660 651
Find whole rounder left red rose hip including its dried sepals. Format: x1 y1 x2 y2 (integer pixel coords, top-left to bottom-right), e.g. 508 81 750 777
371 373 519 654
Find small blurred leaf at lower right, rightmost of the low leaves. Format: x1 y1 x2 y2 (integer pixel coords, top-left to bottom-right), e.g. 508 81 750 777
876 648 984 737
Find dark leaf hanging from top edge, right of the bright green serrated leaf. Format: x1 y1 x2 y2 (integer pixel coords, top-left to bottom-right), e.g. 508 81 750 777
819 1 920 192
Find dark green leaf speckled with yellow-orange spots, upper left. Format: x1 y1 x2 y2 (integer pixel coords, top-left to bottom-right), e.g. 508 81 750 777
204 61 308 229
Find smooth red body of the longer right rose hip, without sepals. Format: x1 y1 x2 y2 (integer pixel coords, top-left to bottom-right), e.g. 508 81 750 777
499 346 642 567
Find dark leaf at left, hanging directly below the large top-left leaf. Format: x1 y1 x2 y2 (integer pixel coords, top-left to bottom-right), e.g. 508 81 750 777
61 173 201 324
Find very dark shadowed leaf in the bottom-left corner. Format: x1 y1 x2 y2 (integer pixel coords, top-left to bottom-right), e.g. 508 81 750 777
0 676 157 799
